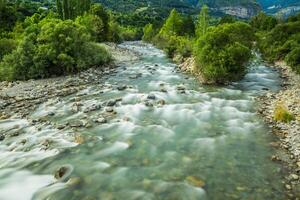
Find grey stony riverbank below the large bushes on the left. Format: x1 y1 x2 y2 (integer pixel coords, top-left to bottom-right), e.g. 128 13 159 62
0 43 138 120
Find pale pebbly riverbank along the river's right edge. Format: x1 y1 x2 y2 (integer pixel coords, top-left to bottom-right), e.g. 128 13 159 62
258 62 300 199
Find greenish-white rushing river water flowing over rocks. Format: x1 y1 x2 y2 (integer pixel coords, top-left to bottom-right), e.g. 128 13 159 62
0 42 284 200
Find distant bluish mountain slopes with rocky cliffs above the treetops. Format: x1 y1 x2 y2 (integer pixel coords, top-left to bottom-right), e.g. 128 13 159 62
94 0 300 18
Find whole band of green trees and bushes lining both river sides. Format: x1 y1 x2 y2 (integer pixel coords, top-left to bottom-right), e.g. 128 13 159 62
0 0 300 84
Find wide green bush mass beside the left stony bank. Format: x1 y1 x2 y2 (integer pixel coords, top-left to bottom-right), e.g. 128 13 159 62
0 15 110 80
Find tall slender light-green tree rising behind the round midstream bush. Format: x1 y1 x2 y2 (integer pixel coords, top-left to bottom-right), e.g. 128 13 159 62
196 5 209 38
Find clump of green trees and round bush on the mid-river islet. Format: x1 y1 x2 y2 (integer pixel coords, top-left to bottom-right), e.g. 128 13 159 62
143 6 255 84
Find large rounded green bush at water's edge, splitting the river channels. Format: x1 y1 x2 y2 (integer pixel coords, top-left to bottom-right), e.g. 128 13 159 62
193 22 254 84
